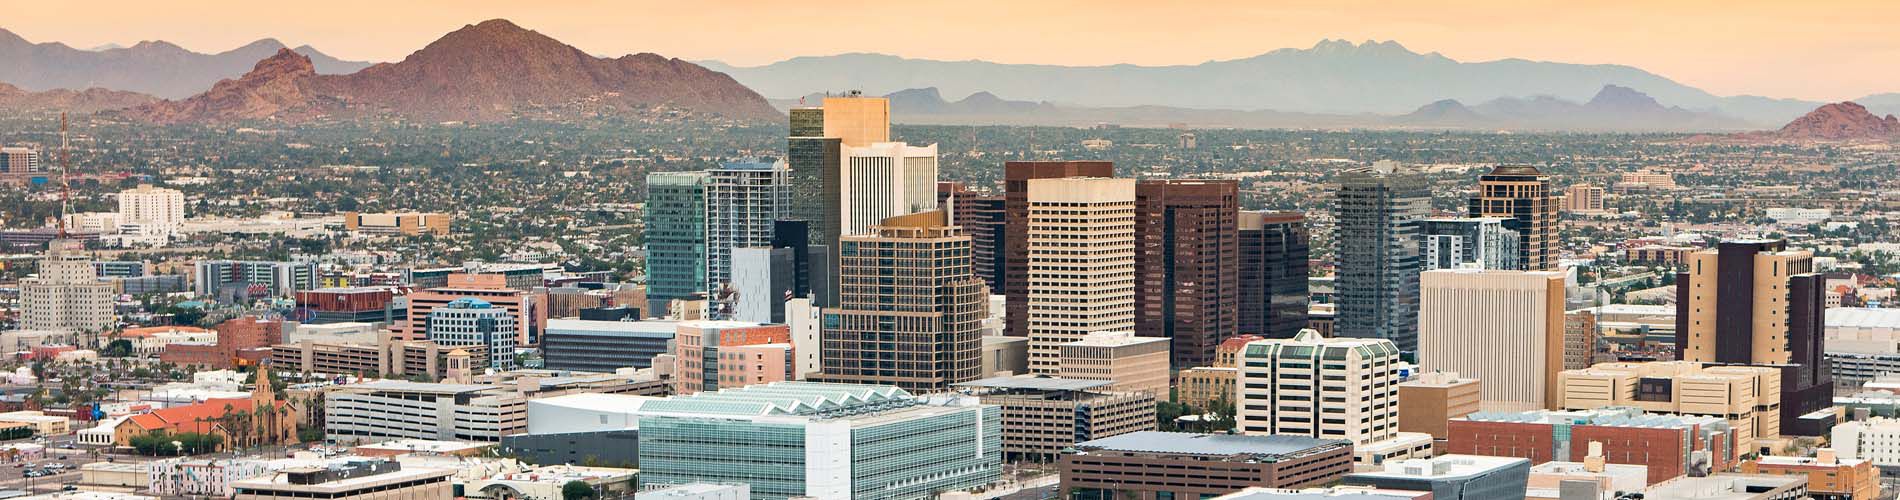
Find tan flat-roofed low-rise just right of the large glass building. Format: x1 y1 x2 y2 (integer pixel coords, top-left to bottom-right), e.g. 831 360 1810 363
956 375 1155 460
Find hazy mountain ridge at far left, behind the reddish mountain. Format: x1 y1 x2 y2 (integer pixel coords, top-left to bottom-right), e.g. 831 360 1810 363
0 29 369 99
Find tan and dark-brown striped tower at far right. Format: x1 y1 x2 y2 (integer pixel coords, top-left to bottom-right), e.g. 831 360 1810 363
1676 240 1834 426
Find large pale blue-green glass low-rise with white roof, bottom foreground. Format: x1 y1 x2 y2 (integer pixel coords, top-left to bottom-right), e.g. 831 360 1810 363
638 382 1003 500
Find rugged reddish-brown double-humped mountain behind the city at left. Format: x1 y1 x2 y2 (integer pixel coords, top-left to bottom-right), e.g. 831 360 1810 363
120 19 783 124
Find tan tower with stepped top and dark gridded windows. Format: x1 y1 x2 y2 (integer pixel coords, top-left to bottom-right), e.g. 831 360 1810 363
817 209 988 392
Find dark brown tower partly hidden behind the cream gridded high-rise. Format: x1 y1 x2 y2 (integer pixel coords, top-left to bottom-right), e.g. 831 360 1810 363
992 162 1132 337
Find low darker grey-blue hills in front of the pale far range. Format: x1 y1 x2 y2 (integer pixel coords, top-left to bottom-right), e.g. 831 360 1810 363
777 86 1759 131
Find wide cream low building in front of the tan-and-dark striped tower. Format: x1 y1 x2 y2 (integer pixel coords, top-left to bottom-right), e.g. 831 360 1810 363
1560 361 1782 451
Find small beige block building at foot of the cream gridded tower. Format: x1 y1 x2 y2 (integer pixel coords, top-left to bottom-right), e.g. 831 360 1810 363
1058 331 1169 397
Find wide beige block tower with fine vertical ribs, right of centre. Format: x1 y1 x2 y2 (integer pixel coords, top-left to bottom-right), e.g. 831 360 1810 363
1419 270 1564 411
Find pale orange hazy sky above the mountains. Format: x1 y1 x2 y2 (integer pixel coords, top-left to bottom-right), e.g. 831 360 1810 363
0 0 1900 101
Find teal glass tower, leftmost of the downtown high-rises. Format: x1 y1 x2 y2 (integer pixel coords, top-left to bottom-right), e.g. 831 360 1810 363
644 171 707 316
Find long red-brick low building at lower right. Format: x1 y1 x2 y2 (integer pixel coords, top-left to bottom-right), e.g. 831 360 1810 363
1446 409 1740 485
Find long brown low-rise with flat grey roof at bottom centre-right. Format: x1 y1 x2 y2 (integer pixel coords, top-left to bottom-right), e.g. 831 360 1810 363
1058 432 1353 500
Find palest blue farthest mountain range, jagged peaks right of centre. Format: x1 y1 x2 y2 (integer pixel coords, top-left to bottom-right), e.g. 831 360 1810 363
703 40 1900 127
